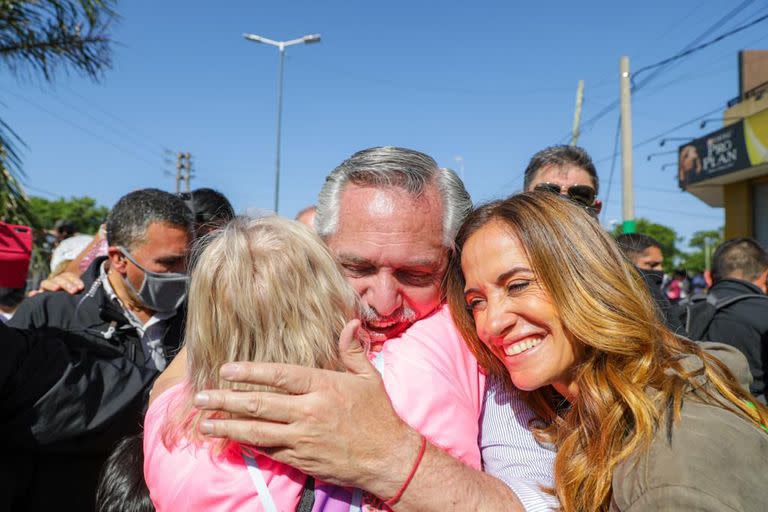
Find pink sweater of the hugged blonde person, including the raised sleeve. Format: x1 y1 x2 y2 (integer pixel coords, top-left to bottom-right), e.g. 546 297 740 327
144 307 485 512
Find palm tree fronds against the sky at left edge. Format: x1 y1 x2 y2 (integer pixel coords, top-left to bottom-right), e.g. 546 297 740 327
0 0 117 227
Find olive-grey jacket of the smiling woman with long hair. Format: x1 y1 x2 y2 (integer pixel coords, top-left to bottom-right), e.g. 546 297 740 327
611 343 768 512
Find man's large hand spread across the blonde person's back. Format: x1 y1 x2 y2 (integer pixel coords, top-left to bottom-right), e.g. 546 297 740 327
195 320 420 499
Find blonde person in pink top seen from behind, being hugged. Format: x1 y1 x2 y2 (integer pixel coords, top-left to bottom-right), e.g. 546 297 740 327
144 217 359 511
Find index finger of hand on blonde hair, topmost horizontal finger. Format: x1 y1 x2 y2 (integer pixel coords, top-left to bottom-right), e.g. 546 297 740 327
220 362 320 395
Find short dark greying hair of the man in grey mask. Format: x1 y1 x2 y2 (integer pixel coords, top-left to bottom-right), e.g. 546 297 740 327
107 188 193 251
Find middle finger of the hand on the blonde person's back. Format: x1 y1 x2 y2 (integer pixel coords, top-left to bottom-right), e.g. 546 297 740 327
194 390 301 423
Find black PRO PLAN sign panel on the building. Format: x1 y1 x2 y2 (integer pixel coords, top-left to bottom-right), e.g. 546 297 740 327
678 121 751 188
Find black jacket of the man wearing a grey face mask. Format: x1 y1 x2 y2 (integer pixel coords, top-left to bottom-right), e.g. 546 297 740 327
8 258 184 510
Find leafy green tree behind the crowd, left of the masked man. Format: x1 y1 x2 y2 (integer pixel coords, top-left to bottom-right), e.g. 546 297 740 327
29 197 109 234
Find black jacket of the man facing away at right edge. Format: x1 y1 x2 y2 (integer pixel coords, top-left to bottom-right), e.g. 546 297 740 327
706 279 768 402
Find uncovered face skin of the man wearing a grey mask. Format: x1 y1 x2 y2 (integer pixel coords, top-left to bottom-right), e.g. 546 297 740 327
125 222 191 290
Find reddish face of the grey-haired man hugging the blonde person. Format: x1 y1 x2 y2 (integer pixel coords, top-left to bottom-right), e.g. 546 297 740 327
326 183 448 345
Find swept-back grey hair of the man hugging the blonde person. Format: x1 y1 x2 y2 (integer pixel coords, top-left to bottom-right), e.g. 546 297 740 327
315 146 472 248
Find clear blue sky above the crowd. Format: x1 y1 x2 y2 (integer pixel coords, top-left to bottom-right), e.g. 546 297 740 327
0 0 768 248
